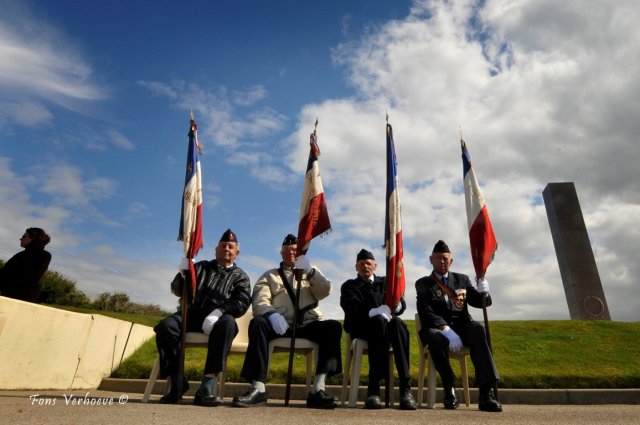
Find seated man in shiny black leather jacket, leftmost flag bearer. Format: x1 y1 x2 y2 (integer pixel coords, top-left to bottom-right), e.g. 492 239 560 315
154 229 251 406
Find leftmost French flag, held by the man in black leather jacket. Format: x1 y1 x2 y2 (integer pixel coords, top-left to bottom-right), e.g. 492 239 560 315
178 113 202 295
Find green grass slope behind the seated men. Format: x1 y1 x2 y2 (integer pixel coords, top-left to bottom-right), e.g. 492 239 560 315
100 313 640 388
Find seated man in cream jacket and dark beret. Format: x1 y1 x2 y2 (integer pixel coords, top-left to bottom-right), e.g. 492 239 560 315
233 234 342 409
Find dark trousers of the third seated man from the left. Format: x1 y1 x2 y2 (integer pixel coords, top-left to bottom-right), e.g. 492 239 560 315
351 316 411 394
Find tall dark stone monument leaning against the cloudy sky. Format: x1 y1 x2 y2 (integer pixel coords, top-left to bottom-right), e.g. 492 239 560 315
542 182 611 320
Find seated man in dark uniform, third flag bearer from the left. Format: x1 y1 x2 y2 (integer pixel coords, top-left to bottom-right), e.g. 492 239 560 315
340 249 416 410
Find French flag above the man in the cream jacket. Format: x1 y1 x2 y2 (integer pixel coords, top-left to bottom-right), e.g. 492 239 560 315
297 120 331 255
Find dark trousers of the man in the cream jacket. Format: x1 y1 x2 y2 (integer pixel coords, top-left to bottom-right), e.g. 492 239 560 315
241 316 342 382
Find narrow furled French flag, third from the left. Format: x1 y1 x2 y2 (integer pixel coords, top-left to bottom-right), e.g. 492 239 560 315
384 124 405 311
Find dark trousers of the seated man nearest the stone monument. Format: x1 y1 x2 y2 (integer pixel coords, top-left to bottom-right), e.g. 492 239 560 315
420 322 500 388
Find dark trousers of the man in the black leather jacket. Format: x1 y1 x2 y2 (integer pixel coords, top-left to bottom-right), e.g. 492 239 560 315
153 313 238 378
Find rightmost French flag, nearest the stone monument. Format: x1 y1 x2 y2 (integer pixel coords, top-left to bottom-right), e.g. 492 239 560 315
460 139 498 279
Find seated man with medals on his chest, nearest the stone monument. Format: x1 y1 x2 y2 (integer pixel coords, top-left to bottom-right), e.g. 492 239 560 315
416 241 502 412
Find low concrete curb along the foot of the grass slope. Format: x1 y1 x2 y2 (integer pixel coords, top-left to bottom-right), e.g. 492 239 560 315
97 378 640 405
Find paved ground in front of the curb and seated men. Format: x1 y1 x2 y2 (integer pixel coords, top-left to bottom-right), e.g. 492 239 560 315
0 390 640 425
